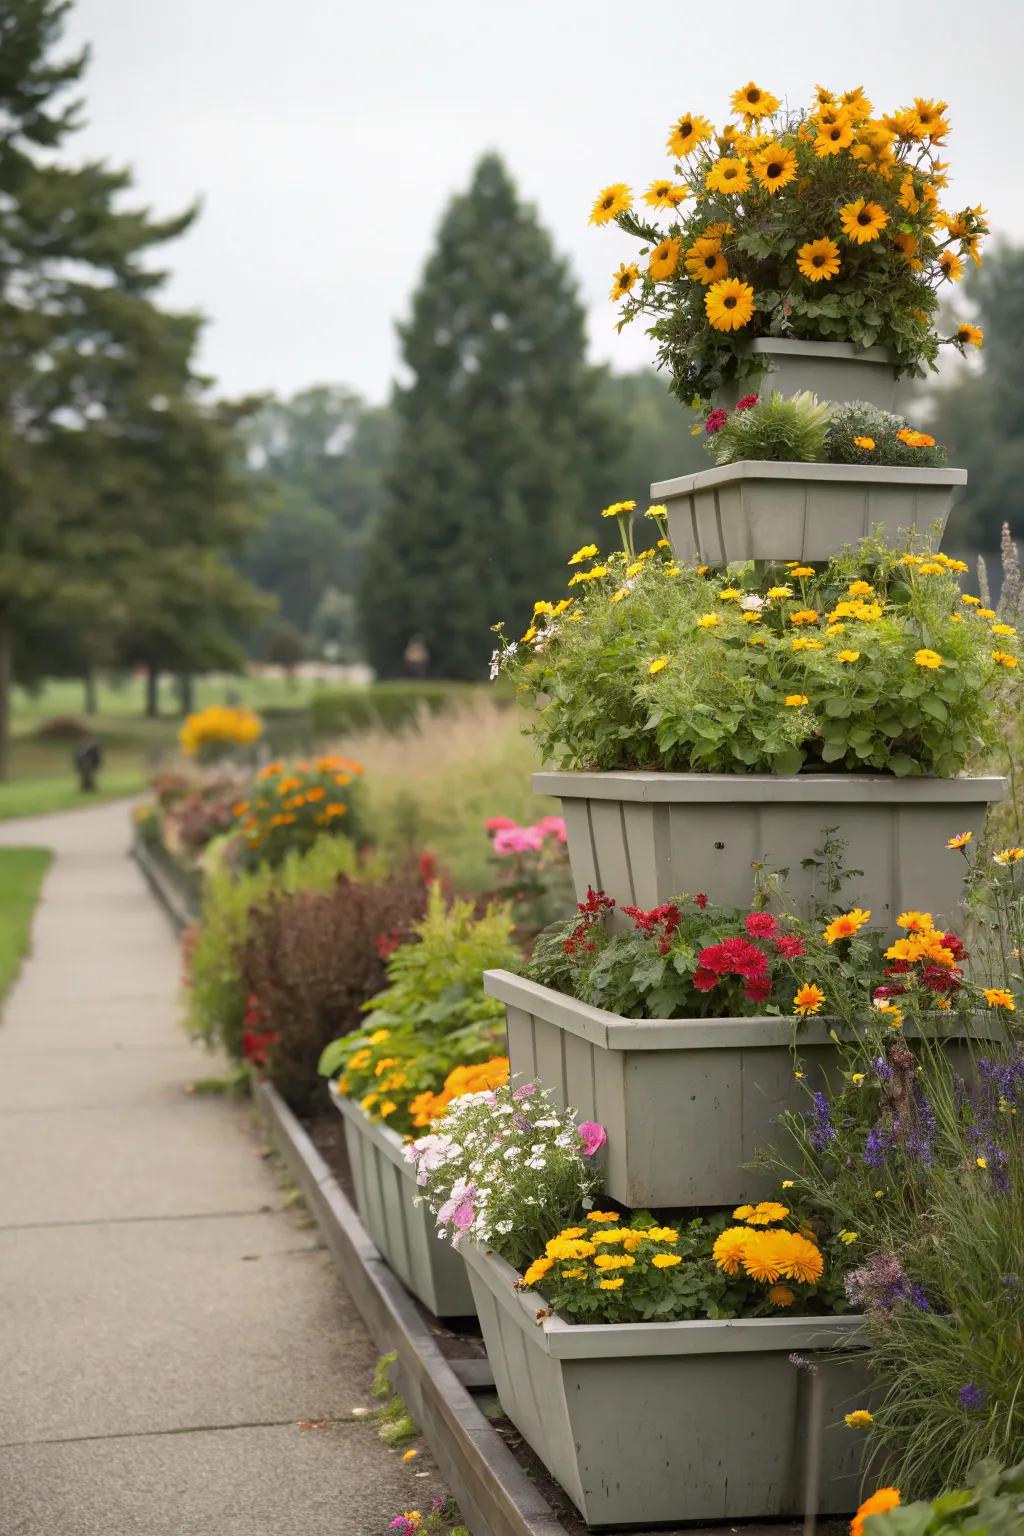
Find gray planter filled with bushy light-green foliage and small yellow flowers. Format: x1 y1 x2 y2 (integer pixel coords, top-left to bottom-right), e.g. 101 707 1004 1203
494 534 1019 923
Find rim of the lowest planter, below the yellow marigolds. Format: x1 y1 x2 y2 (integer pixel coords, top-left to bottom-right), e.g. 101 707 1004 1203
459 1241 864 1359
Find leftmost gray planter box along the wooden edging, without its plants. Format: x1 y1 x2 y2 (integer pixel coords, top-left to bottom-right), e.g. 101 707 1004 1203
330 1092 474 1318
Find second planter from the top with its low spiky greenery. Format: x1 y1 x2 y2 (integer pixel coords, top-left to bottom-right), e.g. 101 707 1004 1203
651 392 967 565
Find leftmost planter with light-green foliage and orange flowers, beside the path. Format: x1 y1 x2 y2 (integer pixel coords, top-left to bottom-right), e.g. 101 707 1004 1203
319 886 519 1316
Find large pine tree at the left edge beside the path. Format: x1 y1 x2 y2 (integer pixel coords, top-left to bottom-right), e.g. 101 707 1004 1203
0 0 263 777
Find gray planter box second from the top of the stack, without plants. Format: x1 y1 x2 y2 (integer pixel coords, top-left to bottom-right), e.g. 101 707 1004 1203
651 459 967 565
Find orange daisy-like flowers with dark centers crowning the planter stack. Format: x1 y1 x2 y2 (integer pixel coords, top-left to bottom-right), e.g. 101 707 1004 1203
590 81 987 365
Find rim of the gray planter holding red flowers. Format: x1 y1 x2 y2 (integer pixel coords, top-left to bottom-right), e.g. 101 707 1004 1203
484 971 1006 1052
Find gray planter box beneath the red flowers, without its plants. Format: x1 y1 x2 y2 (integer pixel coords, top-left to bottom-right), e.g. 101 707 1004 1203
484 971 998 1207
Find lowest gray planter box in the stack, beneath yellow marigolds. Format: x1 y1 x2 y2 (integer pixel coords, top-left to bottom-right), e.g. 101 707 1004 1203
464 1243 867 1527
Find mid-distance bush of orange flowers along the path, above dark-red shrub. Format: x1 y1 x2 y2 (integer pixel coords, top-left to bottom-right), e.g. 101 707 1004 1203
235 753 362 857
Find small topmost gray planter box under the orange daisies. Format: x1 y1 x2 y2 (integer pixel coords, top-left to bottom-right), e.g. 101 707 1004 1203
712 336 900 408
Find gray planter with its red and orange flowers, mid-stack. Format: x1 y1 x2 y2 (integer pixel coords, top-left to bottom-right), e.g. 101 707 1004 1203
485 894 1001 1207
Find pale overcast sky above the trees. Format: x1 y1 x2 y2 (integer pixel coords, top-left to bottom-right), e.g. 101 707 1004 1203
68 0 1024 399
